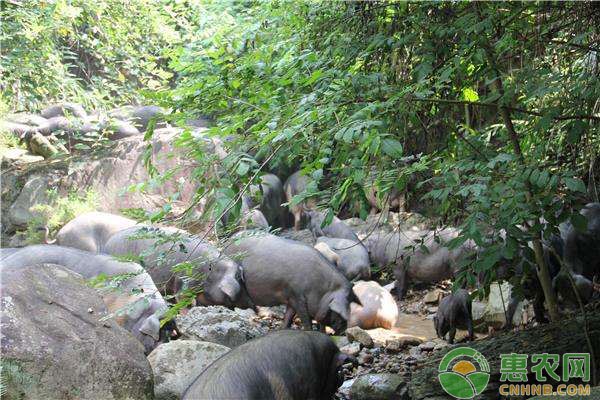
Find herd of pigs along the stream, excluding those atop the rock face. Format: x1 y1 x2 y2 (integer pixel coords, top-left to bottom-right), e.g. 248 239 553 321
0 164 600 399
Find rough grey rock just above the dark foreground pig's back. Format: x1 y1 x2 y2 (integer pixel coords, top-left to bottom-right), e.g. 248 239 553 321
177 306 267 347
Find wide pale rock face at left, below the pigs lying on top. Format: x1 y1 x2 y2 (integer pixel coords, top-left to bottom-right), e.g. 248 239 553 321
1 133 201 233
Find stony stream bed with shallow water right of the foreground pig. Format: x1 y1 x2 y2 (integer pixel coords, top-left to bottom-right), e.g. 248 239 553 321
209 283 484 400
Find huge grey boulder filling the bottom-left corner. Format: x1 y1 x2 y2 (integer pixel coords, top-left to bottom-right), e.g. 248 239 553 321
0 264 153 399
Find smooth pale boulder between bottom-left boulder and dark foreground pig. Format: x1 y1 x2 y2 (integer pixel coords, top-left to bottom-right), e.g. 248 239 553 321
148 340 229 400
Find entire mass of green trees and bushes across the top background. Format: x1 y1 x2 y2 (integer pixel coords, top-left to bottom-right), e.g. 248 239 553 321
1 0 600 320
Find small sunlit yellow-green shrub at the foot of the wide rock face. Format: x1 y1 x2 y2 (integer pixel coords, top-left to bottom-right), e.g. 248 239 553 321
26 190 98 244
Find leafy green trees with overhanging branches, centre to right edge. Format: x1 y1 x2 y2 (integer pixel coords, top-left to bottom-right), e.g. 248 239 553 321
160 1 600 304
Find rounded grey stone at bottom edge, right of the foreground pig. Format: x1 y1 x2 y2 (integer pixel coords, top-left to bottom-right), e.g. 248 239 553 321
350 373 408 400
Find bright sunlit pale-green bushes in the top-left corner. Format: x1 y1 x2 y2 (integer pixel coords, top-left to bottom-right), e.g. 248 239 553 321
0 0 201 110
